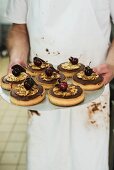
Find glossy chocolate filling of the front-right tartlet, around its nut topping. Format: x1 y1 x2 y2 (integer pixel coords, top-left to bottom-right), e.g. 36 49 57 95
49 86 83 99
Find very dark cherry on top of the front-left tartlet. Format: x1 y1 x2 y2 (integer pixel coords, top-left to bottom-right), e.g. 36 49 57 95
24 77 35 90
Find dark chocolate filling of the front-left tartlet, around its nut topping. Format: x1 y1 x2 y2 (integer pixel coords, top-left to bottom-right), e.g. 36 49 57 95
10 85 43 101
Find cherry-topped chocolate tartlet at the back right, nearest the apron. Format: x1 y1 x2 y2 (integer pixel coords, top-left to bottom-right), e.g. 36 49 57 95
57 57 84 77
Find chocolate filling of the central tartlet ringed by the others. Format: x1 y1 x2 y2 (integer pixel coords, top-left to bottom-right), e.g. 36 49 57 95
38 73 66 84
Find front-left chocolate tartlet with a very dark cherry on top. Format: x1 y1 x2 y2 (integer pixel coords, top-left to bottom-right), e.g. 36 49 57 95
10 78 45 106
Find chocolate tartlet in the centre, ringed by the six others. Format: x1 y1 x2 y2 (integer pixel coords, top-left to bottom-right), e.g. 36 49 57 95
37 67 66 89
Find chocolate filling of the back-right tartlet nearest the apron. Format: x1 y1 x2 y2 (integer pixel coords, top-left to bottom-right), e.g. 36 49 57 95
57 63 85 73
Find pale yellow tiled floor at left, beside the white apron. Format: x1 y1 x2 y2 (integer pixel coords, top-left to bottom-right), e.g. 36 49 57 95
0 58 27 170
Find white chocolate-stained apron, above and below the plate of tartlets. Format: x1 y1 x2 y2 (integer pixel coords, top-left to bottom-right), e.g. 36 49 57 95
27 0 110 170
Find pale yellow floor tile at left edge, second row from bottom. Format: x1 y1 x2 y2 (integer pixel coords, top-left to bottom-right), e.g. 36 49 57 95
1 152 20 164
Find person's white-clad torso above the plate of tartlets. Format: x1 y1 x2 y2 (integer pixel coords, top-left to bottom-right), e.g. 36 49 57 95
27 0 111 66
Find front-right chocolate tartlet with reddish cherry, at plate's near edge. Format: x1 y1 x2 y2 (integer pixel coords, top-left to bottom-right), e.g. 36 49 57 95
48 82 84 106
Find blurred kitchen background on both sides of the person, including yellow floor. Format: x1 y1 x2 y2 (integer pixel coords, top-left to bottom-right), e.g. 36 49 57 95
0 0 114 170
